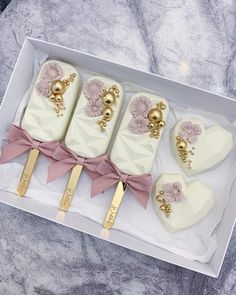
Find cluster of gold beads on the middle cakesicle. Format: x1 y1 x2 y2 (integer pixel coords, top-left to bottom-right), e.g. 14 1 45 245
97 85 120 131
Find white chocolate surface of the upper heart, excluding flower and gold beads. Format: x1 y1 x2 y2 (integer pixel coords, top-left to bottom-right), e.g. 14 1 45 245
171 119 233 176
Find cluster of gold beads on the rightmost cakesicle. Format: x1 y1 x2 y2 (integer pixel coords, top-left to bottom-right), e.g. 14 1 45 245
148 102 166 138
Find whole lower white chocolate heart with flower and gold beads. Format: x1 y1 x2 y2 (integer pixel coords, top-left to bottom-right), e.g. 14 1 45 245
153 174 214 232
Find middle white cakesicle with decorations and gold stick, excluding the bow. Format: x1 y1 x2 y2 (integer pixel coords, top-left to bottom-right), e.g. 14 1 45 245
55 76 123 211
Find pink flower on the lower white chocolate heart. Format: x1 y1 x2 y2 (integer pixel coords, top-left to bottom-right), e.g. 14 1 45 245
162 182 184 203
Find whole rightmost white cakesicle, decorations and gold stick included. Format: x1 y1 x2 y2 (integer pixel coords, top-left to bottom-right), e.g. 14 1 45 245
98 92 169 229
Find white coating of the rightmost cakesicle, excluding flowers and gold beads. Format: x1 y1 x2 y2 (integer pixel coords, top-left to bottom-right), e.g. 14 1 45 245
111 92 169 175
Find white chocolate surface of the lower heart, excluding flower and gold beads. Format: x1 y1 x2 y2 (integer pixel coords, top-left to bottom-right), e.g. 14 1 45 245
153 174 214 232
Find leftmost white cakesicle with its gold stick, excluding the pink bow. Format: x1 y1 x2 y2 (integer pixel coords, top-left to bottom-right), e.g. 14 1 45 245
17 60 80 196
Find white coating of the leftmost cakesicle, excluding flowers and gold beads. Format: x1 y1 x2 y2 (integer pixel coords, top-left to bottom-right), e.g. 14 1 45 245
21 60 80 142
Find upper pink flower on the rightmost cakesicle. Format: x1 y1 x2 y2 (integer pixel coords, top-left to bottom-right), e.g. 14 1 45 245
129 96 152 118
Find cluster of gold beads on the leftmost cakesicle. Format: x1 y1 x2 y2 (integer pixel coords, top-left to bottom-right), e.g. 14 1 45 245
48 73 76 117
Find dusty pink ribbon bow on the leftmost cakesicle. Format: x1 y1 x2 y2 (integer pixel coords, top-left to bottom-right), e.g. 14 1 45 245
0 125 59 163
